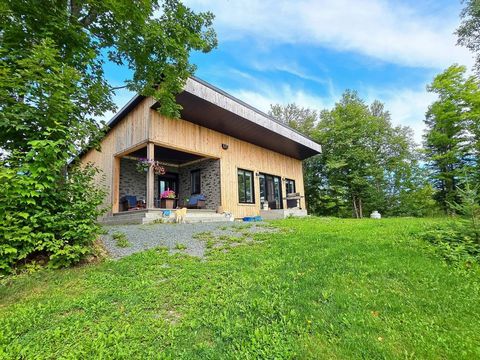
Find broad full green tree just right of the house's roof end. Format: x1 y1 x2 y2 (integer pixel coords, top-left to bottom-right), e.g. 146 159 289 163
318 91 415 218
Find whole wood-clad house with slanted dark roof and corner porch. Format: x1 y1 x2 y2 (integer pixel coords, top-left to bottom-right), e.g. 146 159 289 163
81 77 321 219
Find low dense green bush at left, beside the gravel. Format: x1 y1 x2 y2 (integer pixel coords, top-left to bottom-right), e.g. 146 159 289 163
0 140 105 273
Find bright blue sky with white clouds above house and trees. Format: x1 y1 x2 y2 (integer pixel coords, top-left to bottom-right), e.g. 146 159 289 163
107 0 473 141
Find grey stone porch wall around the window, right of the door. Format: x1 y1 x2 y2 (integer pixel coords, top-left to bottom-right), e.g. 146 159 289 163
178 159 221 210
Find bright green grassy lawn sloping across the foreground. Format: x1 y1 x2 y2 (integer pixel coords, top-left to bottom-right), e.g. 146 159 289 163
0 219 480 359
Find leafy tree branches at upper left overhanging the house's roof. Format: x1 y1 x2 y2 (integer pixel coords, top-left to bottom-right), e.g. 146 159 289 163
0 0 216 156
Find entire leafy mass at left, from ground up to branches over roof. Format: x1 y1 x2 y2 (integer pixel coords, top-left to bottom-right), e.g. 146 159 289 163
0 0 216 271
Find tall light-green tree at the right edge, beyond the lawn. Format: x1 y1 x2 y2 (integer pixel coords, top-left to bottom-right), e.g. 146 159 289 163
424 65 480 212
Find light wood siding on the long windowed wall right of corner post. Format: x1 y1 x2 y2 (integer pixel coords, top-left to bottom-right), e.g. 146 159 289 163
149 112 305 217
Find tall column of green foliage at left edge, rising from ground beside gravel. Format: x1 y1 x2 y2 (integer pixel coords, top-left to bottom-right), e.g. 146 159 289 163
0 41 105 272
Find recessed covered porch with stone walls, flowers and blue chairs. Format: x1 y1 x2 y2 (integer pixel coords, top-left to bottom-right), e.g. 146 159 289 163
112 142 221 215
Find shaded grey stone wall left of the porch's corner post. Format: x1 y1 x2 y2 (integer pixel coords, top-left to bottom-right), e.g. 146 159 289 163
119 158 147 200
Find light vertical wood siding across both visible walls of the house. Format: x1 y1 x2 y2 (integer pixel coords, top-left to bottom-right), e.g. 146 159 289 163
82 98 305 218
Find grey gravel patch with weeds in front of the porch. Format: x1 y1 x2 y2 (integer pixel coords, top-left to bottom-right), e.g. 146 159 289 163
102 222 278 259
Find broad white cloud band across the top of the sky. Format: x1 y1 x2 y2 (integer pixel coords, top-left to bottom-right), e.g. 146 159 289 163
187 0 473 68
